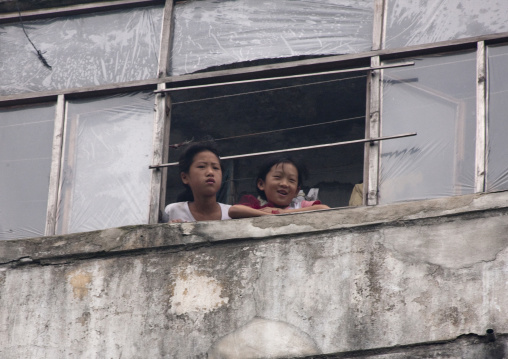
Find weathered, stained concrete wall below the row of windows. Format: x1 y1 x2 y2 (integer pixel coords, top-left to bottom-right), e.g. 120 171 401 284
0 192 508 359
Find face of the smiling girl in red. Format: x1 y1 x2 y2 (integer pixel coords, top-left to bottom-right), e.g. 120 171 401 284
258 163 298 208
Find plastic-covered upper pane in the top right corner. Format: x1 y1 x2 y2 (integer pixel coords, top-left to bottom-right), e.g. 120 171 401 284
384 0 508 48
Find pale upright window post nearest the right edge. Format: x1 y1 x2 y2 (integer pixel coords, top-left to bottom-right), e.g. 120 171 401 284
475 41 487 193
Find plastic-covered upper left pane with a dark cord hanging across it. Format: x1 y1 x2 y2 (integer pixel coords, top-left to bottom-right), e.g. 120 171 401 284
0 6 162 95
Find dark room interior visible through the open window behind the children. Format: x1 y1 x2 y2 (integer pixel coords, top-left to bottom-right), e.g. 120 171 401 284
166 73 366 207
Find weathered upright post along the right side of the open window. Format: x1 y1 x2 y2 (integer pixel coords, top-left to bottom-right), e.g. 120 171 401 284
363 56 381 206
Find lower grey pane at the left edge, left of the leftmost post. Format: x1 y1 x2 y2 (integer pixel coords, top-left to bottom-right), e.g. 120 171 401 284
0 104 55 239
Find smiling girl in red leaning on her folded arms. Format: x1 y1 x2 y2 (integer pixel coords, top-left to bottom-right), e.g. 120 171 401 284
229 157 330 218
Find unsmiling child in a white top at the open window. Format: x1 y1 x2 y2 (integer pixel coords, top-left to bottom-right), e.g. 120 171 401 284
162 142 231 223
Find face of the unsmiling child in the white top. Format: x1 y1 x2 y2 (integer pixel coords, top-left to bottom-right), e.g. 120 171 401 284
180 151 222 199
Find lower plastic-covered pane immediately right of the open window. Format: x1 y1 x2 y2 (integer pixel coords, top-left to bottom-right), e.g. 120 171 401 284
379 53 476 203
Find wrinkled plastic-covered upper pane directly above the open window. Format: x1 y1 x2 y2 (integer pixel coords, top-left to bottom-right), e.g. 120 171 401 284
172 0 374 75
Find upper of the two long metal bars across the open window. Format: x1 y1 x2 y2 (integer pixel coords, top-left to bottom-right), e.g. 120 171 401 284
154 61 415 93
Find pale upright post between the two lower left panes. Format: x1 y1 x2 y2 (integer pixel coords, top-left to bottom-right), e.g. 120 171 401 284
45 95 65 236
